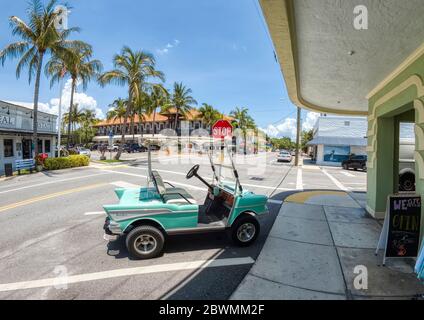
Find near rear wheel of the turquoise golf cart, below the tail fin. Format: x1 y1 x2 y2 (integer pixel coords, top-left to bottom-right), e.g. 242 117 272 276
126 226 165 259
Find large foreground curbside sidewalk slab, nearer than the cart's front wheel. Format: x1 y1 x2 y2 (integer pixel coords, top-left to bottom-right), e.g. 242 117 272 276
250 237 345 294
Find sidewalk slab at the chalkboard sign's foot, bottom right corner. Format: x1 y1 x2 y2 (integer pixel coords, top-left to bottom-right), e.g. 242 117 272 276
338 248 424 299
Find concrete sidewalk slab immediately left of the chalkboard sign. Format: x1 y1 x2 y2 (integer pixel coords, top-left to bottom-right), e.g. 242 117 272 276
329 221 381 249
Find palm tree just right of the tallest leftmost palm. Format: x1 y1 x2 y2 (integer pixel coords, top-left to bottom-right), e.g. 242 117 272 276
45 44 102 148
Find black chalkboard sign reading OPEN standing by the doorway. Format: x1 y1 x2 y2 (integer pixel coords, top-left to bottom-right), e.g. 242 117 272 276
376 194 421 263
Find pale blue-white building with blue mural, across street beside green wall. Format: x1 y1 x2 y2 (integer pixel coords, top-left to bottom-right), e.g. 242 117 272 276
308 116 367 166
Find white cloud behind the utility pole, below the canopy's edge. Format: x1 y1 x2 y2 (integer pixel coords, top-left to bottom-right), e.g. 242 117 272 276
261 112 319 141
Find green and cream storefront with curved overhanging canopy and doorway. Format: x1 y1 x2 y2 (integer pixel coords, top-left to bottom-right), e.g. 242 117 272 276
260 0 424 238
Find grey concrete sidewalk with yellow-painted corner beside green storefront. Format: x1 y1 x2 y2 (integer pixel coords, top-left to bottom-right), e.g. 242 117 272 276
231 191 424 300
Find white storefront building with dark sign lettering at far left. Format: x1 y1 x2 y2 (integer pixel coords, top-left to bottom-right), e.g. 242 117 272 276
0 100 57 176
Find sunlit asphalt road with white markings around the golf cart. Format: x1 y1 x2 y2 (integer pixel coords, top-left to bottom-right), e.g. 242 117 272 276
0 154 366 299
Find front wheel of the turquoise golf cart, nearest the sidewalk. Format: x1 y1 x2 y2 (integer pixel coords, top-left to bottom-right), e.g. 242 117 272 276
231 215 260 247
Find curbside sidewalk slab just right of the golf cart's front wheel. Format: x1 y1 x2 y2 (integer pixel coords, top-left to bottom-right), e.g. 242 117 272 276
269 216 333 246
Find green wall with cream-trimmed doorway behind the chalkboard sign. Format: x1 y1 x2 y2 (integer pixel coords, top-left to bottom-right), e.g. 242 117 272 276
367 50 424 240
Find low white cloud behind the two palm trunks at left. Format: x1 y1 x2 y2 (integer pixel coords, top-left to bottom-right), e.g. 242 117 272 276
9 79 105 119
